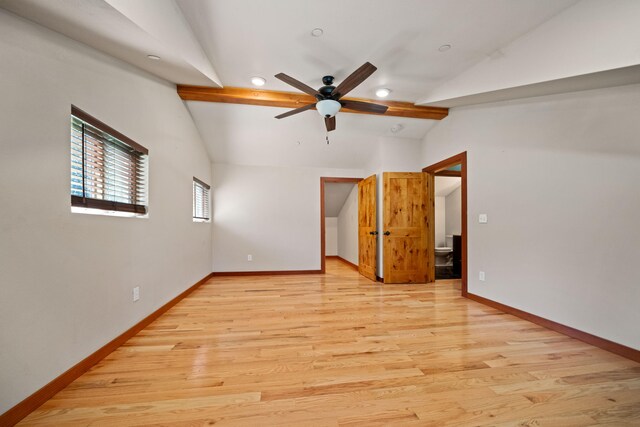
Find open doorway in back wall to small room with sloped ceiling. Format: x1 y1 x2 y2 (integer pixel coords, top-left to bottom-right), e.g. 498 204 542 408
320 177 362 273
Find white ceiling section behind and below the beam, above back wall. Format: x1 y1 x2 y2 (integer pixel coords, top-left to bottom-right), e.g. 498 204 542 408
187 101 436 169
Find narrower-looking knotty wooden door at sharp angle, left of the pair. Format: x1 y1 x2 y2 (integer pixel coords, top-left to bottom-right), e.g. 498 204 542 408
358 175 378 281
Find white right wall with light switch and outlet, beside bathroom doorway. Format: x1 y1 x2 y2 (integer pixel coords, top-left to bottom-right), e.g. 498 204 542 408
424 85 640 349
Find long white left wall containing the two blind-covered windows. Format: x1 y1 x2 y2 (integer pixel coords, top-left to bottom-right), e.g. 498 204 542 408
0 10 211 413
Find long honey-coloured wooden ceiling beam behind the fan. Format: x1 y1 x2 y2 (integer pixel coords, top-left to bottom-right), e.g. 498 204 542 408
178 85 449 120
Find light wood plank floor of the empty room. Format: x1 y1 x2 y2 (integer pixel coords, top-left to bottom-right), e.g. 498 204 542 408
23 260 640 426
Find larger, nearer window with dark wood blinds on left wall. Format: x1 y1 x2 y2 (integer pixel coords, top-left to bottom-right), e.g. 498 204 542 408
71 106 149 215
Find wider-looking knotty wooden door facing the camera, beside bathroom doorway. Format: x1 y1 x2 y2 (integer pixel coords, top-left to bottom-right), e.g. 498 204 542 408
382 172 435 283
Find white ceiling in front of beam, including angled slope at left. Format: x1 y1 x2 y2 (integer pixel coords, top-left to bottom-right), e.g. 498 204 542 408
0 0 577 102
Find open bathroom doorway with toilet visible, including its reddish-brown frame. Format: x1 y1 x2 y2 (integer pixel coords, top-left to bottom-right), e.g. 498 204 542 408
422 151 468 296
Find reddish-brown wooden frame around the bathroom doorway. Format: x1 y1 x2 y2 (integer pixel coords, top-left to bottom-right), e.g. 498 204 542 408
422 151 469 297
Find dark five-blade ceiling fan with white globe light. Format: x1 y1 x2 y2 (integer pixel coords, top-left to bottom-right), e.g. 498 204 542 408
275 62 388 132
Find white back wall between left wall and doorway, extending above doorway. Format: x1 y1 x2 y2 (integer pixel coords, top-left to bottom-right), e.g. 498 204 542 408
213 163 363 271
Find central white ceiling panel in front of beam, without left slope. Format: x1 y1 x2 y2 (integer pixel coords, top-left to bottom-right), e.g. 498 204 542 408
177 0 575 102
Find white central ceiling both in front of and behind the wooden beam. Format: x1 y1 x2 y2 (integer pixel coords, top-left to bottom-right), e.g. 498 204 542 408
178 0 574 168
